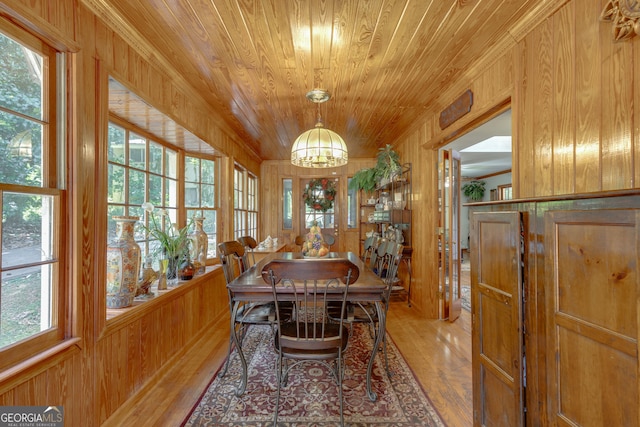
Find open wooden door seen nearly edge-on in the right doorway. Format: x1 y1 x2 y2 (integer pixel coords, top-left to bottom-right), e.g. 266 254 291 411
438 150 462 322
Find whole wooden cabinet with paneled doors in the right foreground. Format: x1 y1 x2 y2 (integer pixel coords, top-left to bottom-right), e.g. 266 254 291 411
470 191 640 426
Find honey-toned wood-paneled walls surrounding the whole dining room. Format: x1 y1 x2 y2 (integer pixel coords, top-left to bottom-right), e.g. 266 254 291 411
0 0 640 425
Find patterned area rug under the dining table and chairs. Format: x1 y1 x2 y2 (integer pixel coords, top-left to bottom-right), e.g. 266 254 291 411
182 324 444 427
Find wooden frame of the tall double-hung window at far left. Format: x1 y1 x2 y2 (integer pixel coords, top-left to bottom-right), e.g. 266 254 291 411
0 18 68 370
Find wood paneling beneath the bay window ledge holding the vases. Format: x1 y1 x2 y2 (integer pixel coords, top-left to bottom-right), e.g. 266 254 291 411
94 268 229 423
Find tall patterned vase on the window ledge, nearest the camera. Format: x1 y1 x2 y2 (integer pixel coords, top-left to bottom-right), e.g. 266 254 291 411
107 216 140 308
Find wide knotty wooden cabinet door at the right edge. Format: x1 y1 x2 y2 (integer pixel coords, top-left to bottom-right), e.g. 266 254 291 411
544 209 640 426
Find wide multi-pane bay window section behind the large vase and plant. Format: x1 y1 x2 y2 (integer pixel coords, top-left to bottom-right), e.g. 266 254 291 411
107 122 178 268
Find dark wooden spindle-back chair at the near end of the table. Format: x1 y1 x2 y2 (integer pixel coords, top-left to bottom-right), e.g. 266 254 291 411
262 259 360 426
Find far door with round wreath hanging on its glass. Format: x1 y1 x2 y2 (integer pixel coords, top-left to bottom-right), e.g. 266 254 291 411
300 178 340 252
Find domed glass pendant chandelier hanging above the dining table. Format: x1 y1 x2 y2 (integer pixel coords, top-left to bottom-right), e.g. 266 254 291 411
291 89 349 168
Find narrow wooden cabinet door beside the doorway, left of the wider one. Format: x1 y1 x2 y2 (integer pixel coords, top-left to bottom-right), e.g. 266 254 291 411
471 212 524 426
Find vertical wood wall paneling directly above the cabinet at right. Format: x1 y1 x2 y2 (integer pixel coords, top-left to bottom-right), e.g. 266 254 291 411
514 0 640 197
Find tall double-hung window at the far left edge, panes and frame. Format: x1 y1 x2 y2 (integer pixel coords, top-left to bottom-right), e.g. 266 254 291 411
0 21 66 369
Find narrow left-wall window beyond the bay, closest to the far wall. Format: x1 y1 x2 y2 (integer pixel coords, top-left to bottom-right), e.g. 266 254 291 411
233 166 258 240
